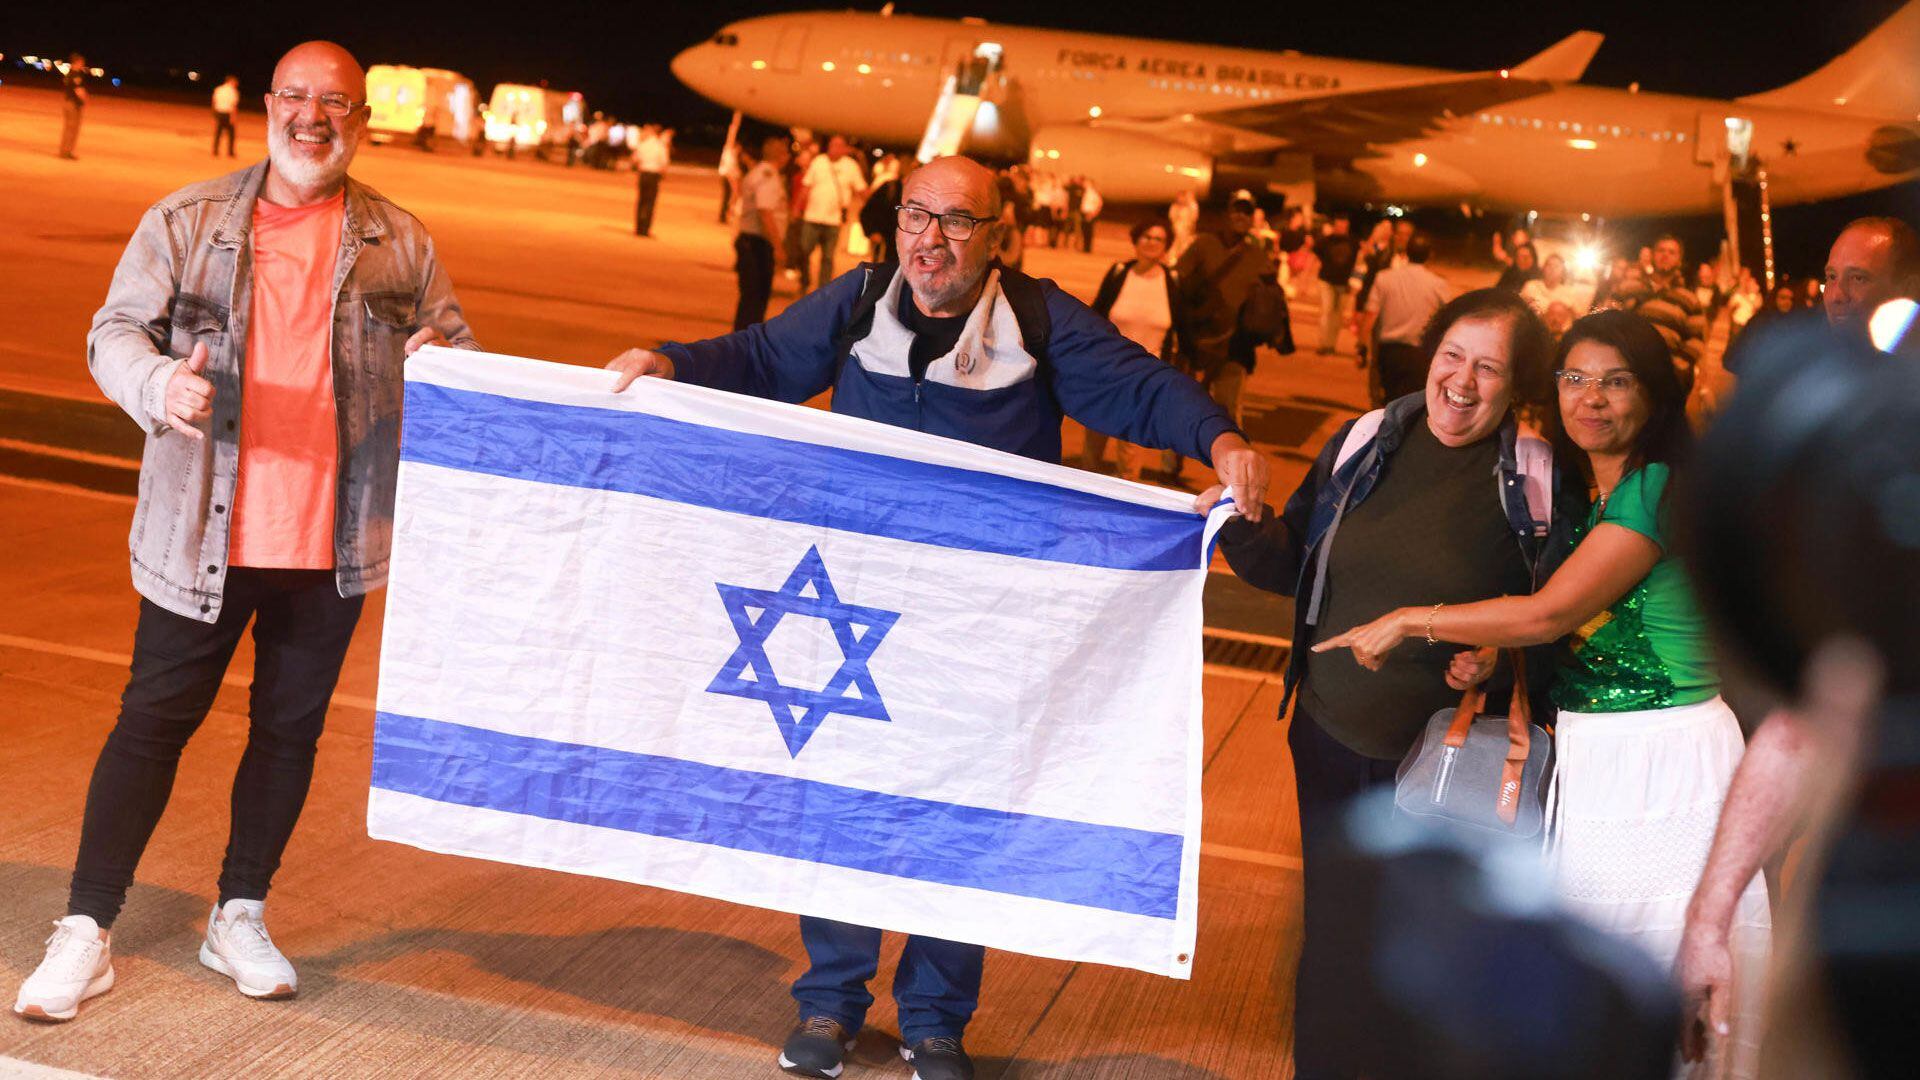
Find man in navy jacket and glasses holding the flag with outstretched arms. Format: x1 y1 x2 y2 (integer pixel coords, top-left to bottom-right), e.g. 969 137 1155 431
607 158 1267 1080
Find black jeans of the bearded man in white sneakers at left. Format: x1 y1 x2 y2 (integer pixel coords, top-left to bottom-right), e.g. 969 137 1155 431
67 567 365 926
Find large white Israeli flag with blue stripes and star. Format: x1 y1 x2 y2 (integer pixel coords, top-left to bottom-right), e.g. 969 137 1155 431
367 348 1210 978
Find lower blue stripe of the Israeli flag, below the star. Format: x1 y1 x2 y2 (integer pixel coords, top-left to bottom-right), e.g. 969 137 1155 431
372 713 1183 919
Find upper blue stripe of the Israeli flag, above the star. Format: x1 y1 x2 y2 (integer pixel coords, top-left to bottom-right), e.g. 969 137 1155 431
401 382 1206 571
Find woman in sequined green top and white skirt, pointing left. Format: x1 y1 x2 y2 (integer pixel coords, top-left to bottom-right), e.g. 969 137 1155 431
1313 311 1770 1076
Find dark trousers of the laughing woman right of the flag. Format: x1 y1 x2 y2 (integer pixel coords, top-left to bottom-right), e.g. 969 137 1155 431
1286 707 1400 1080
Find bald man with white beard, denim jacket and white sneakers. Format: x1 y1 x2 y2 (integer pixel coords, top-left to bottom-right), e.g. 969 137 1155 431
13 42 478 1020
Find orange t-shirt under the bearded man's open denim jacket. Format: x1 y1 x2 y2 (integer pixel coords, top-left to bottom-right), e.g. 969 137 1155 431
227 192 346 571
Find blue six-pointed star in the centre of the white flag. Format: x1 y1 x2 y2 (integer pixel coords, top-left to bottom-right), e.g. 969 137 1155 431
707 546 900 757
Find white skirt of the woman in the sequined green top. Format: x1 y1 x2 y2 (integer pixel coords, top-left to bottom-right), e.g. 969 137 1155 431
1548 698 1772 1080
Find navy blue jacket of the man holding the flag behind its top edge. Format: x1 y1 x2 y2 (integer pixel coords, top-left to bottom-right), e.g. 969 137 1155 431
659 267 1238 463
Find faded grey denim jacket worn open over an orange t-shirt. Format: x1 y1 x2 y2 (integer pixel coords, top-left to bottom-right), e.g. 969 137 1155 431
86 161 480 623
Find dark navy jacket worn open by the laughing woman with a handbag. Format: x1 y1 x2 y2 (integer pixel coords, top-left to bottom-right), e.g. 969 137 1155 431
1219 392 1586 723
